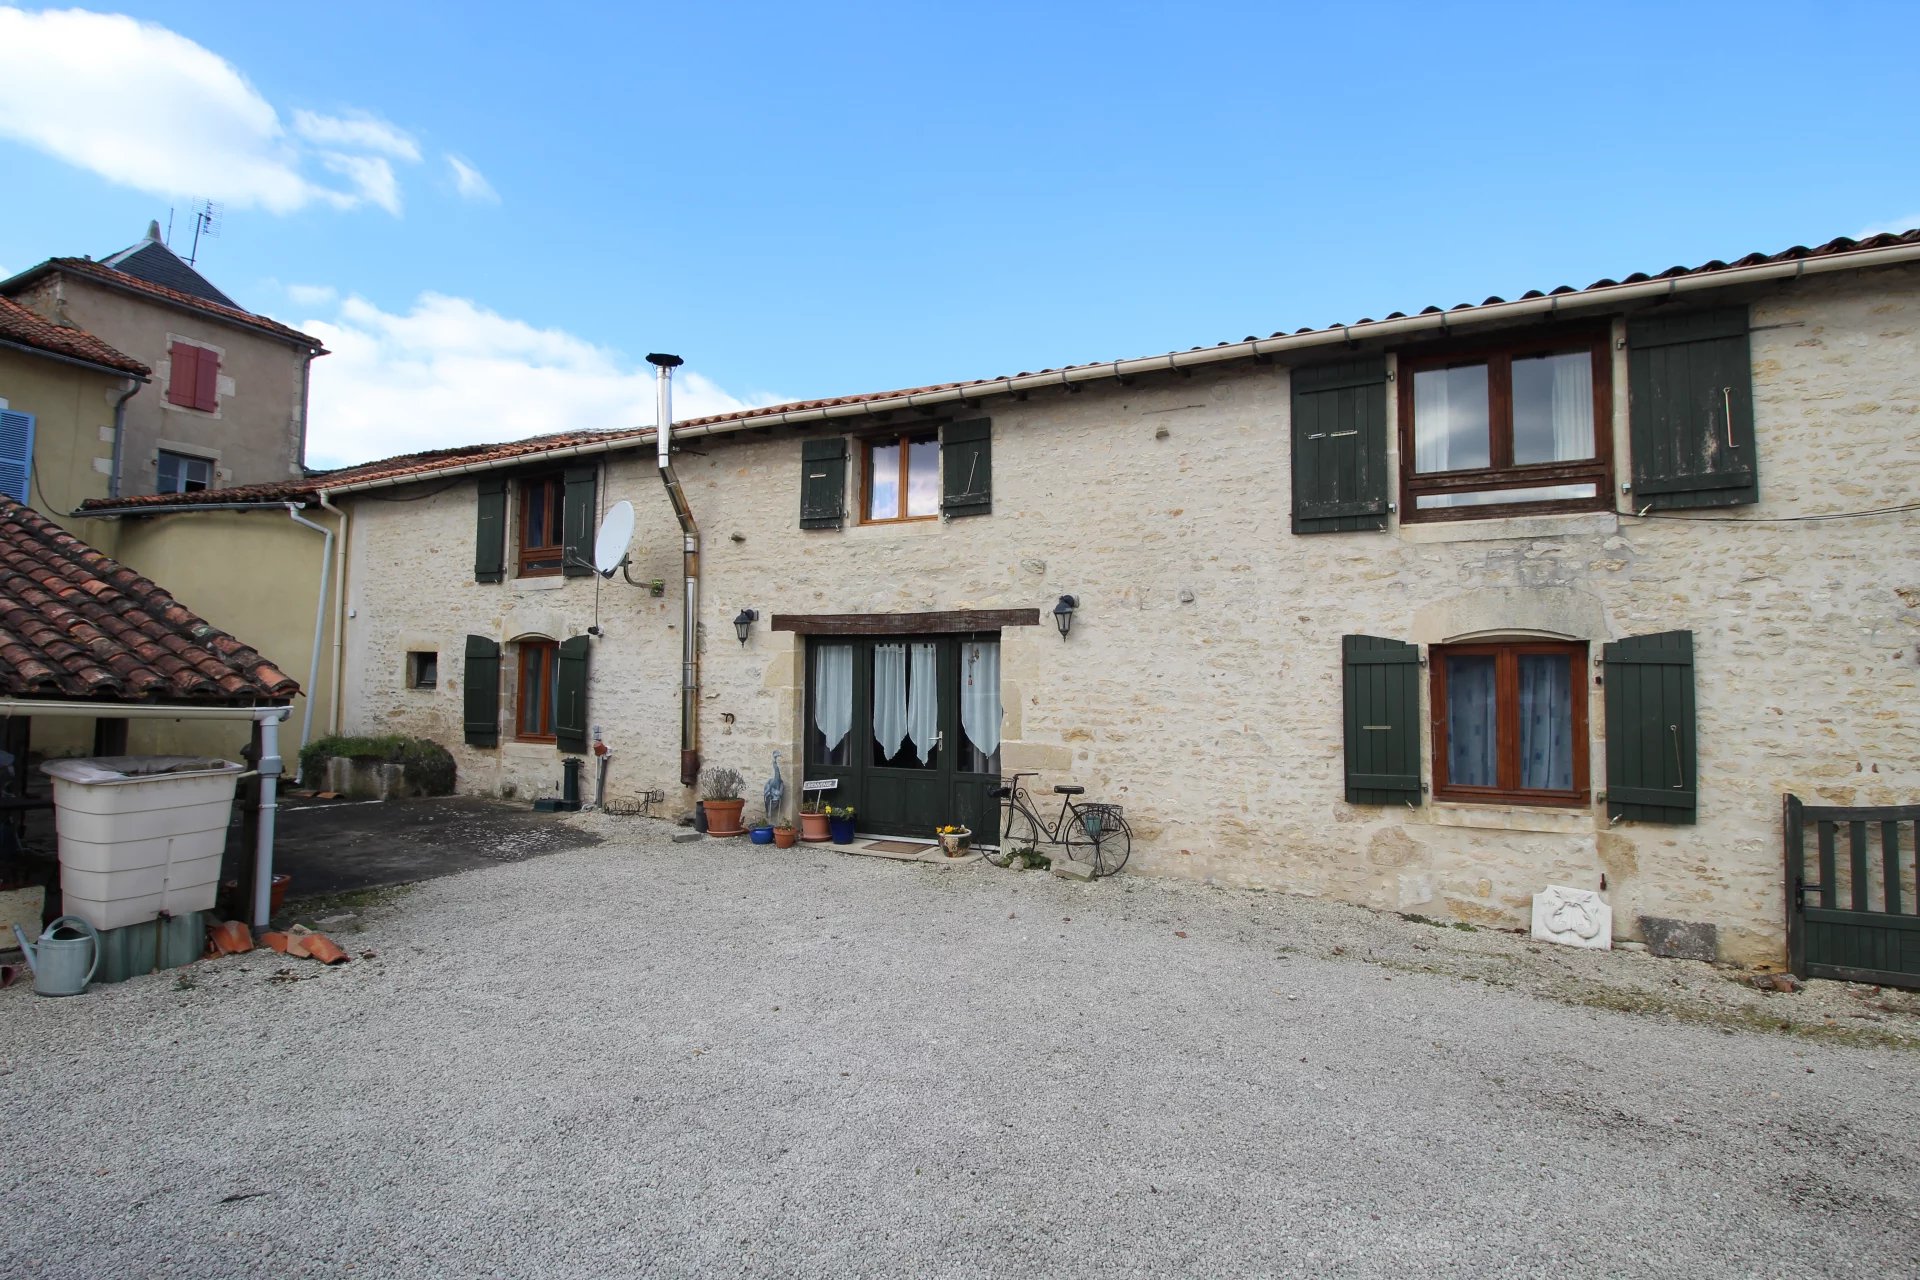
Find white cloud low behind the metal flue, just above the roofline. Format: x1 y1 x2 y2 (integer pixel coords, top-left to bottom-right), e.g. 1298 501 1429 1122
296 286 776 466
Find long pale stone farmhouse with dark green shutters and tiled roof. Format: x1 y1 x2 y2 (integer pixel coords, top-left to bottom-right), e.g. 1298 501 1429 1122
97 232 1920 961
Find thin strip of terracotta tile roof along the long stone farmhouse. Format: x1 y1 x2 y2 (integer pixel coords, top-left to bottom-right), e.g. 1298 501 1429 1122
84 228 1920 510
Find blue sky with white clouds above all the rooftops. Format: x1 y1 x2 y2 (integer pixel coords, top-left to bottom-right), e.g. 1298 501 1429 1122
0 0 1920 464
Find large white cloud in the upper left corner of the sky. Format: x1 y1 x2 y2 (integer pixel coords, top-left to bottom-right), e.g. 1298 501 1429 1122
0 6 441 215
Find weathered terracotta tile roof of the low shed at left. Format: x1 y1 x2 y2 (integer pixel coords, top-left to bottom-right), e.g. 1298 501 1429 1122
0 497 300 704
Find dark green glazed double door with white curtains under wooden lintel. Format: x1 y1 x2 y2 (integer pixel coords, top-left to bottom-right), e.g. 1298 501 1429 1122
804 631 1002 844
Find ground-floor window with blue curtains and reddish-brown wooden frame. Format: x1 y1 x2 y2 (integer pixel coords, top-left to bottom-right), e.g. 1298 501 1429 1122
1432 641 1590 804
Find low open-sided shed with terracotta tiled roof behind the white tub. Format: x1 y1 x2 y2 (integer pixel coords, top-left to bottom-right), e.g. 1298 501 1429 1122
0 497 300 936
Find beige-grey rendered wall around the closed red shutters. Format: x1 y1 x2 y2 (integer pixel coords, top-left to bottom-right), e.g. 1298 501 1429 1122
19 273 305 495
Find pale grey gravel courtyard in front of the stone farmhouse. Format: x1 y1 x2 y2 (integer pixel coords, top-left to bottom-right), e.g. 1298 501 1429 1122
0 818 1920 1276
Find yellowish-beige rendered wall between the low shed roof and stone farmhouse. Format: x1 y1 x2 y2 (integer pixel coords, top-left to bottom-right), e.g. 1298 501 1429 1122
92 510 334 771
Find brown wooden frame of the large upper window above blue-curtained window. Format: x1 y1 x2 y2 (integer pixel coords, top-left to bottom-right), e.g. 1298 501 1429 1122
1394 328 1613 524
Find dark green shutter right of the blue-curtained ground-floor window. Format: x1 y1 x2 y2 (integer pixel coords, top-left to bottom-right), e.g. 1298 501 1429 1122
1601 631 1699 823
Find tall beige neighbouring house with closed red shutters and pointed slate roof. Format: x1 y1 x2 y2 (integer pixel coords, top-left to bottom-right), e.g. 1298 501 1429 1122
0 223 326 497
